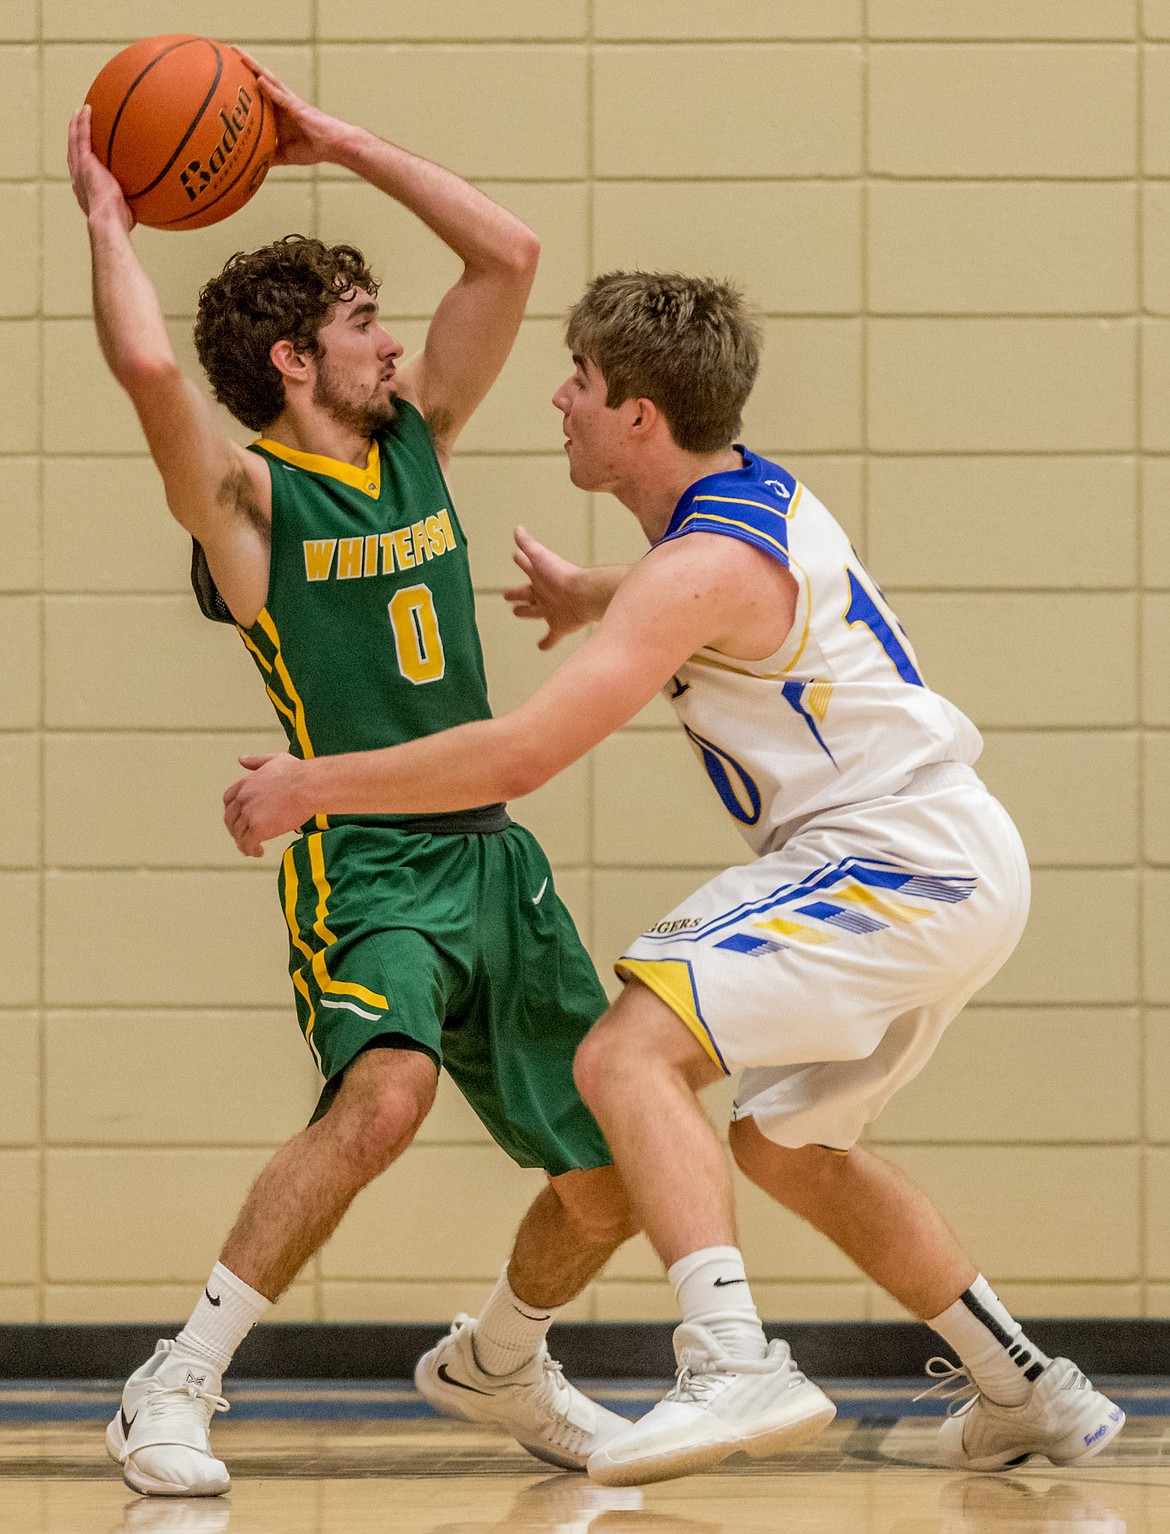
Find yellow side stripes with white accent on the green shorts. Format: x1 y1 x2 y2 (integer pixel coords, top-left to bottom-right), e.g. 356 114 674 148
281 831 389 1075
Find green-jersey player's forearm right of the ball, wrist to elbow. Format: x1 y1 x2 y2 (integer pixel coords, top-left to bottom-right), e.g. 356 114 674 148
331 129 540 273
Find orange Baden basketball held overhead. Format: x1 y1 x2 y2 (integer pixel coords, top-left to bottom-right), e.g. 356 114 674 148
86 34 276 229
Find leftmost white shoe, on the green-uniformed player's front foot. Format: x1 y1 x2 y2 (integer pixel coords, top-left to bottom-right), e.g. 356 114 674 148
106 1339 232 1497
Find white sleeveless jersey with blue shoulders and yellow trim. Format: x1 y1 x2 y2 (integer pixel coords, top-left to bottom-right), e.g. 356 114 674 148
661 448 983 853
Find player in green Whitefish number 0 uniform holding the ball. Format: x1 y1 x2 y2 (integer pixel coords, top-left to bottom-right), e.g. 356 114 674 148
69 66 632 1496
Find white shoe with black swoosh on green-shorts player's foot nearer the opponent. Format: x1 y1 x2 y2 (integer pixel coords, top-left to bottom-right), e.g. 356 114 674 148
414 1316 630 1470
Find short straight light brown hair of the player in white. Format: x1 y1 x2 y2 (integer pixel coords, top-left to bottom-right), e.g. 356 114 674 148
564 272 762 453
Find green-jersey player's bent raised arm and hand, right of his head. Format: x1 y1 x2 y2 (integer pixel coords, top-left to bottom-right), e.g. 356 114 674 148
244 54 540 459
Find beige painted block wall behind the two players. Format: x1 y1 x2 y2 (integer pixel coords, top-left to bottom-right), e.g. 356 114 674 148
0 9 1170 1321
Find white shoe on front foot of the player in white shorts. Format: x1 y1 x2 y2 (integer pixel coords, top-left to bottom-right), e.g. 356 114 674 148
589 1322 837 1486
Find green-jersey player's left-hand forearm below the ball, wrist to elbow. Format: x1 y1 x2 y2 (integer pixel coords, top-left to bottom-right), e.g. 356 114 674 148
89 215 176 393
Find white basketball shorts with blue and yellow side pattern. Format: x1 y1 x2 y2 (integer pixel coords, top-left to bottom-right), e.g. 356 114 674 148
615 762 1030 1151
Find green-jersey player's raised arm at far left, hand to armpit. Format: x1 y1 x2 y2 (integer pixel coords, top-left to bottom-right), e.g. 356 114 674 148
69 106 270 621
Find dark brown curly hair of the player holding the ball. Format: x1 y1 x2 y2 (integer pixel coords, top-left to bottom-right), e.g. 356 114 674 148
195 235 379 431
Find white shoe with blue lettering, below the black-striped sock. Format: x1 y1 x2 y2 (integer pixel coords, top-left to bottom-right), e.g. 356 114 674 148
923 1358 1126 1470
